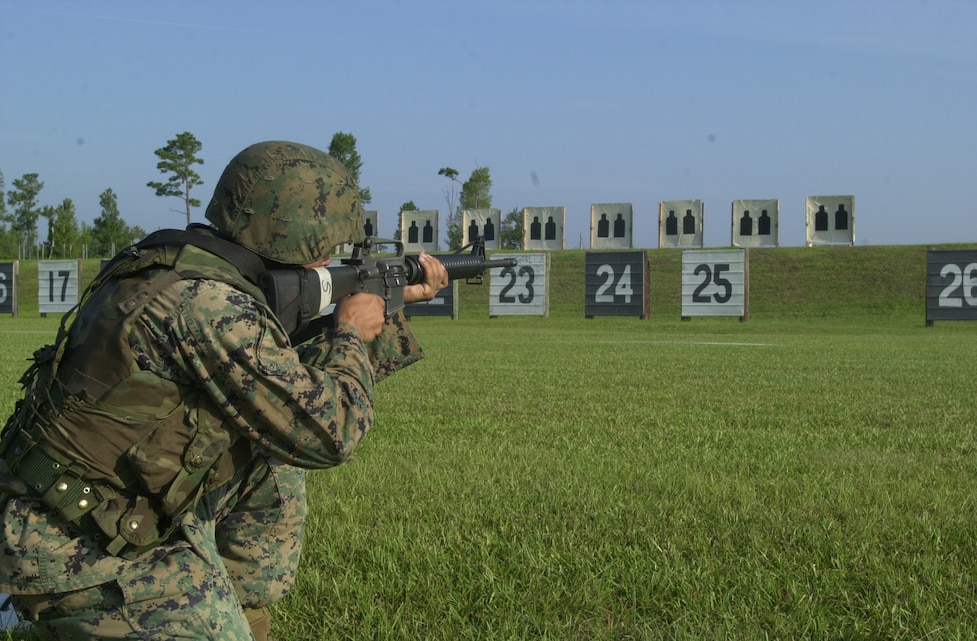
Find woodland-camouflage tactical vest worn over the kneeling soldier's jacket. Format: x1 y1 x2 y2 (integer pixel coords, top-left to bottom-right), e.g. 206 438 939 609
0 230 265 559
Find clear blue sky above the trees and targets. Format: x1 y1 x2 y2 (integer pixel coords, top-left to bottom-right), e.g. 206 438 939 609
0 0 977 248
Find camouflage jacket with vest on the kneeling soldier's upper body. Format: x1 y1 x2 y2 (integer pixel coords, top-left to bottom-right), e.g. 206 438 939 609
0 236 423 592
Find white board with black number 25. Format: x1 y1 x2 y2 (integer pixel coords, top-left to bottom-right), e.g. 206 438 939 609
682 249 750 321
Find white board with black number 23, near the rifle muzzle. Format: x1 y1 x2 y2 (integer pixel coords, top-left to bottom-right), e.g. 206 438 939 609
489 253 550 316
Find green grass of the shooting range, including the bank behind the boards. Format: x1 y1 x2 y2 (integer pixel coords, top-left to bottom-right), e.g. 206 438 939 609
0 247 977 641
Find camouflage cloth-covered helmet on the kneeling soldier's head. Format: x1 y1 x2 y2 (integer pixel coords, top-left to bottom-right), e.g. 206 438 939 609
206 141 363 265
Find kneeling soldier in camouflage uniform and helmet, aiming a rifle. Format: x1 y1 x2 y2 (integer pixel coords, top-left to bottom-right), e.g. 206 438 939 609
0 142 448 640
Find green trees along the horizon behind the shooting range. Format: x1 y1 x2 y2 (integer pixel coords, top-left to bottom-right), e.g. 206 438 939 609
0 132 522 259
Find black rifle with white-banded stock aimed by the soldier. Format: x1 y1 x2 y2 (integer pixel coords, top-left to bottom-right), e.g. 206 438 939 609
258 236 516 345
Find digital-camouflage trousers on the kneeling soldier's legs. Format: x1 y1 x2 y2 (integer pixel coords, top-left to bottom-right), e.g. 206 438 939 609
14 459 306 641
